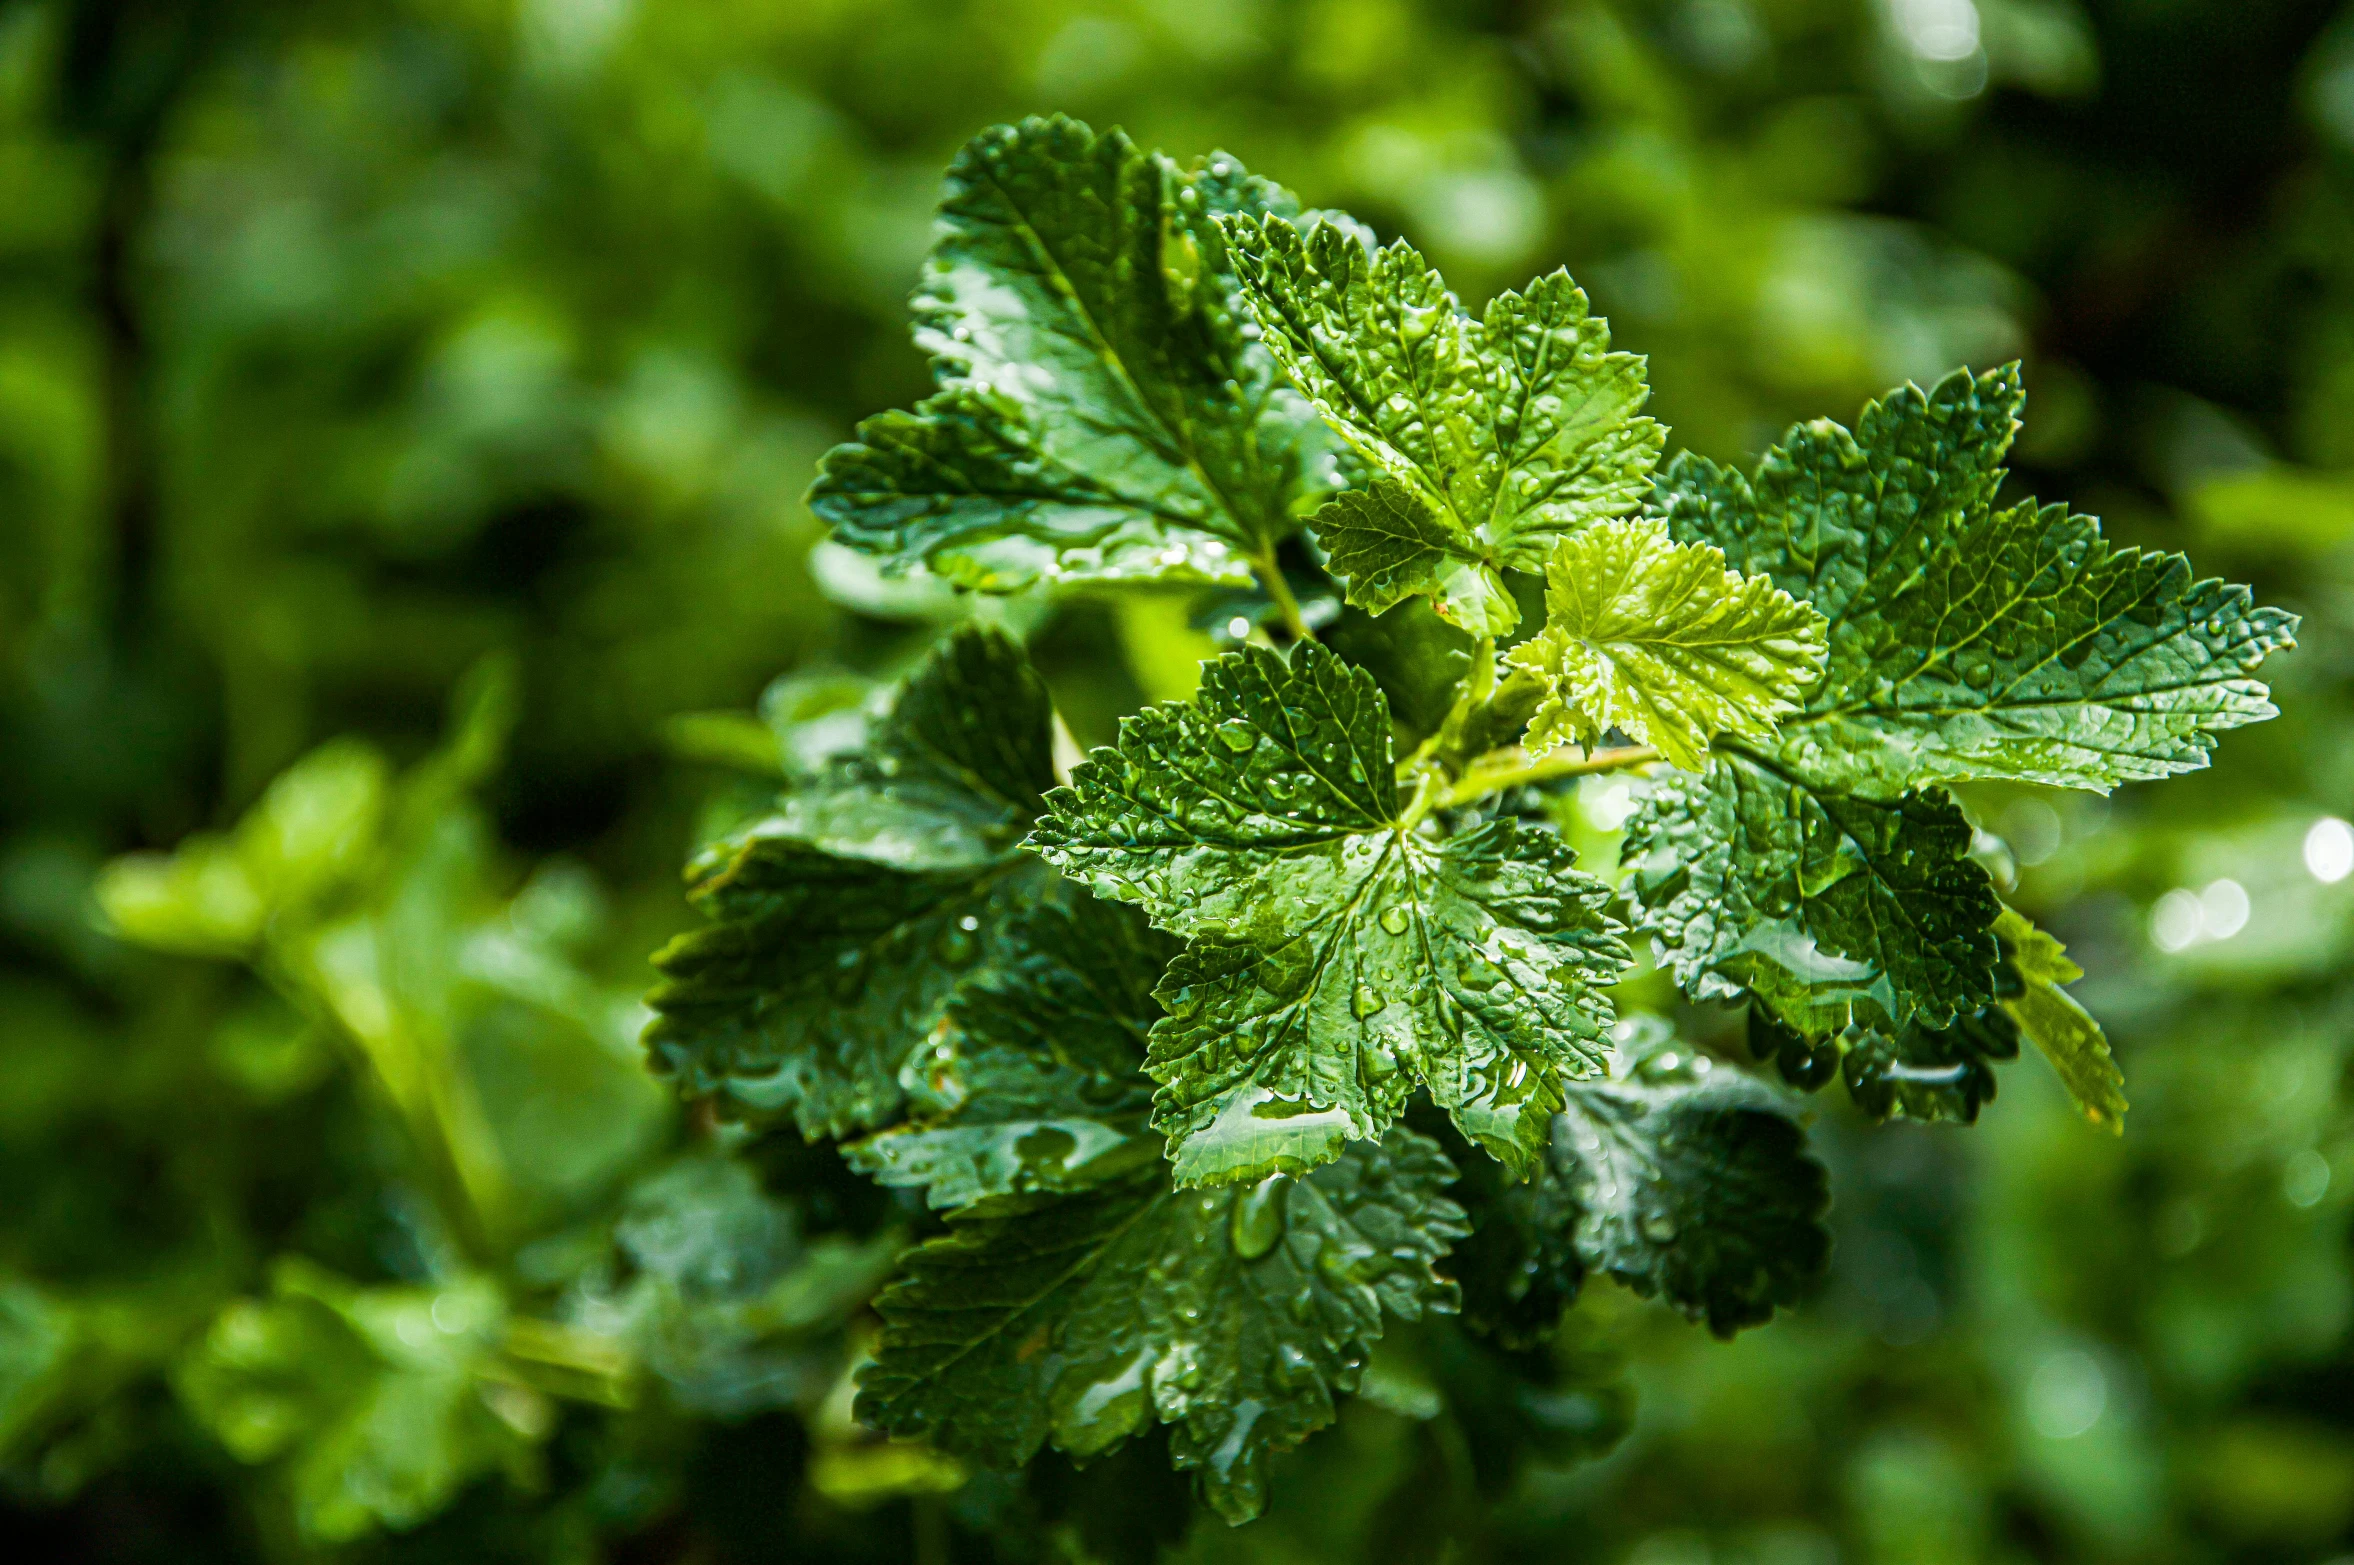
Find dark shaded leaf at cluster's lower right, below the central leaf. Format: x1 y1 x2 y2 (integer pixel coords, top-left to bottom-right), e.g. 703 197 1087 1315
1457 1026 1831 1341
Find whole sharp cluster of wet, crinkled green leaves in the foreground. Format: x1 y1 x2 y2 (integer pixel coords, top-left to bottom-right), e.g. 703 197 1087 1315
647 107 2293 1520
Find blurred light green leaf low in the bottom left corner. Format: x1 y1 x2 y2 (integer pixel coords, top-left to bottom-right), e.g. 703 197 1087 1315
177 1259 529 1541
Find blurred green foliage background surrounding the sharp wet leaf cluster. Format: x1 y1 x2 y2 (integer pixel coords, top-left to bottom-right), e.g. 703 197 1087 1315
0 0 2354 1565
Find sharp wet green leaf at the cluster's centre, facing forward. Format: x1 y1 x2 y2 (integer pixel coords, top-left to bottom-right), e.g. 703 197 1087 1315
1031 642 1627 1184
